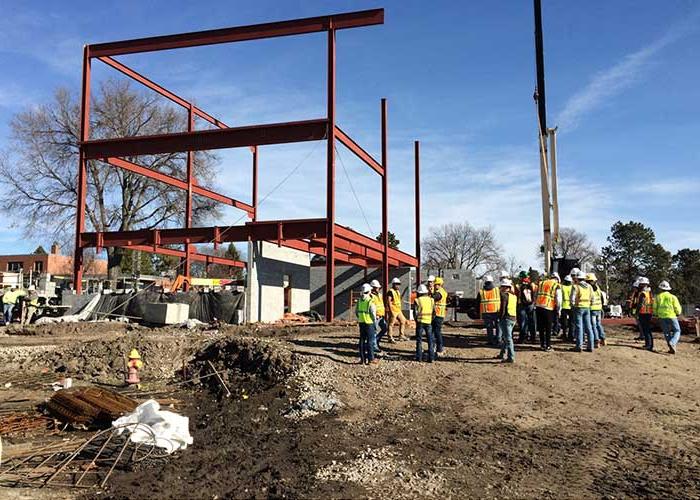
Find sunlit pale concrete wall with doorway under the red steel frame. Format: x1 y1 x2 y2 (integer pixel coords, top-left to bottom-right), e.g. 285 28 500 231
246 242 311 322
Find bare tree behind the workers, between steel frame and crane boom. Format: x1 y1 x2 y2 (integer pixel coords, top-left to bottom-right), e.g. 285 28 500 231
422 222 503 274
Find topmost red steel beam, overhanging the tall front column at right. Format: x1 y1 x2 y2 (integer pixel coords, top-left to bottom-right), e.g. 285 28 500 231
88 9 384 57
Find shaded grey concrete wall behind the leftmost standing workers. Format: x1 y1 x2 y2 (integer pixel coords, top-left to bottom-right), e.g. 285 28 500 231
311 266 412 320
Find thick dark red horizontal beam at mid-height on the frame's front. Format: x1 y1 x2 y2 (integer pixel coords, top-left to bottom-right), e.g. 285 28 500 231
80 119 328 159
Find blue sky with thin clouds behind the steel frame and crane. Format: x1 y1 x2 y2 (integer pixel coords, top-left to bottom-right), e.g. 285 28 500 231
0 0 700 265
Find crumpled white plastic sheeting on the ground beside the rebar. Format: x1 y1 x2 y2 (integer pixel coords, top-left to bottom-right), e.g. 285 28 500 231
112 399 192 453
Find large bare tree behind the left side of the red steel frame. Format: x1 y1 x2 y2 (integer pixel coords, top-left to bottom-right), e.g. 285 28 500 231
0 80 219 278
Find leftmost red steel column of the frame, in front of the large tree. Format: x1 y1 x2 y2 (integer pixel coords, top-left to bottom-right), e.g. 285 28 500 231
73 45 90 294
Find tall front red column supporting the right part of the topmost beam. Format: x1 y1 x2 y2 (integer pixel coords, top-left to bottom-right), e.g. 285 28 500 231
326 24 335 321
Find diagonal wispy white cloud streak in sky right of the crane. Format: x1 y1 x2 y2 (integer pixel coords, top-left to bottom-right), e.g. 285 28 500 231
557 11 700 132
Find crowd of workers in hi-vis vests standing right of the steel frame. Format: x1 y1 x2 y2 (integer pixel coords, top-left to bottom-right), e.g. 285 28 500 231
356 268 681 364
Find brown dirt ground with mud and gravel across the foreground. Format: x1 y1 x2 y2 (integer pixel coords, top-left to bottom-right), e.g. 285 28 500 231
0 326 700 499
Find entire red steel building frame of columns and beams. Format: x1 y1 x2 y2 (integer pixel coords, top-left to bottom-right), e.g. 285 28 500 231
74 9 420 321
